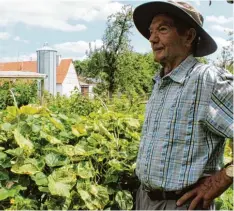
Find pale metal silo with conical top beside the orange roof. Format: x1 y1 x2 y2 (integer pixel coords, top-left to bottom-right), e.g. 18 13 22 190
37 43 57 95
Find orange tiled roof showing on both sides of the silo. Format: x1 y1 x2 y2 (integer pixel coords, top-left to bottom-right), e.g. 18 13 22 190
0 59 72 84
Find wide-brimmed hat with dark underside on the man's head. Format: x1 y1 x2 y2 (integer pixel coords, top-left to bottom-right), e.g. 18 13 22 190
133 1 217 57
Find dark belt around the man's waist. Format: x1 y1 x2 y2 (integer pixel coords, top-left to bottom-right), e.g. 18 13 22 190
142 184 194 201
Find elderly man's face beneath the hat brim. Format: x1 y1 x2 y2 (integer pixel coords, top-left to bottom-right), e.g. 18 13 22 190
149 14 187 64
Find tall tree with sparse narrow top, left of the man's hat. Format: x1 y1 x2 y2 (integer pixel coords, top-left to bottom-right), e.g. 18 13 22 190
87 5 133 98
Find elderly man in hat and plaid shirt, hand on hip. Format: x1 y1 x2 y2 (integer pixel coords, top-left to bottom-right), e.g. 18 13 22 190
133 2 233 210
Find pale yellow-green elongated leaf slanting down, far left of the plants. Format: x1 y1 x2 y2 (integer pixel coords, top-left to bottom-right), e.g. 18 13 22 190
13 128 33 154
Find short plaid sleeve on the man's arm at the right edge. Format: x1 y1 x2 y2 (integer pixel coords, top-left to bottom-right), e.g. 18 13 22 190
206 70 234 138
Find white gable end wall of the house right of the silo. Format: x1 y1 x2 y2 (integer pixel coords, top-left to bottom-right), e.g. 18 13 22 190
62 63 81 96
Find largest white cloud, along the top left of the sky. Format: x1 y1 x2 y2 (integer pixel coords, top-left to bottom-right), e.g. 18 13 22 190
0 0 122 32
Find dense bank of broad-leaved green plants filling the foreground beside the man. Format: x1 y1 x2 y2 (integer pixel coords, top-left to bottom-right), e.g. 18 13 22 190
0 102 143 210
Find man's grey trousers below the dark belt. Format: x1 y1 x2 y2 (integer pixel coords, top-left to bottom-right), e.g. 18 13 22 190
136 185 215 210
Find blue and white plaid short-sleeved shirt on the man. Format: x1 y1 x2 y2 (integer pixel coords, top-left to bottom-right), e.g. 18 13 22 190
136 55 233 191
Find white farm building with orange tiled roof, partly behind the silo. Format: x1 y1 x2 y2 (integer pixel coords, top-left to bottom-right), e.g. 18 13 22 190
0 59 81 96
